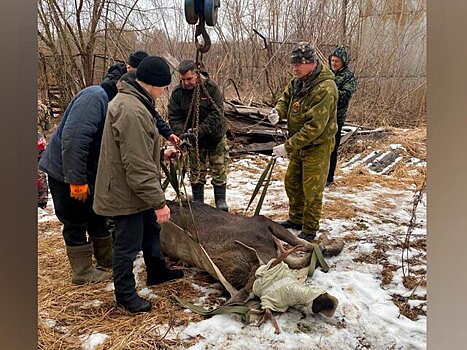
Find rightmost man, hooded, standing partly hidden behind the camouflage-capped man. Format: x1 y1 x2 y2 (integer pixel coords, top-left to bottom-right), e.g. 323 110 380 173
326 47 357 185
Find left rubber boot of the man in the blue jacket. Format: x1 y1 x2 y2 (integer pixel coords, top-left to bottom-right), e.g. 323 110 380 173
66 243 112 284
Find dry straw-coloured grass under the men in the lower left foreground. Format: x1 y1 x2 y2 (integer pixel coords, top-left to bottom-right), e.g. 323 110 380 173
38 226 223 350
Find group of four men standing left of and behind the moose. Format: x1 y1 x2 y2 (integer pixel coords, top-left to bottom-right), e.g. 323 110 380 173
39 51 228 313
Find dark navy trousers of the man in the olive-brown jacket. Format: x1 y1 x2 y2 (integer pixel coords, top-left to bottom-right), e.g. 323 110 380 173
113 209 163 302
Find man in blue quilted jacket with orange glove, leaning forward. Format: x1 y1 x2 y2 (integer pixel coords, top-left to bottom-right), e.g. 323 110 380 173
39 68 123 284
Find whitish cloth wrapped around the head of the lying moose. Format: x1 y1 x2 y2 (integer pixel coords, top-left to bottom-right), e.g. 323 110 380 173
253 259 324 312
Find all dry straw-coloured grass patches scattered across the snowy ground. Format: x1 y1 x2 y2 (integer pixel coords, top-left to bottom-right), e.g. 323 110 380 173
38 129 426 350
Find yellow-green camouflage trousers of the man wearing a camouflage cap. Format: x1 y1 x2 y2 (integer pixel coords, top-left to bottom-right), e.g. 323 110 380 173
285 139 334 233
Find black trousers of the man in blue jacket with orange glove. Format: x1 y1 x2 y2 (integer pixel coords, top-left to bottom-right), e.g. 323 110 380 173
48 176 109 246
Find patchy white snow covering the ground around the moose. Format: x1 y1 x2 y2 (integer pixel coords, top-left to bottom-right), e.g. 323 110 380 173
38 155 427 350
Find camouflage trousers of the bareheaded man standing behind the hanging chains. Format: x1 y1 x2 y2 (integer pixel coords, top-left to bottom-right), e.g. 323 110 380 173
189 136 229 186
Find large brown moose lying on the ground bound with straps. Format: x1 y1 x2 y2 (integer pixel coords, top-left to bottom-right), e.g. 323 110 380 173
161 201 343 330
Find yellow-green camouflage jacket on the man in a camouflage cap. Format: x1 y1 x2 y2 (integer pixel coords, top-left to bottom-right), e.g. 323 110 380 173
276 63 337 154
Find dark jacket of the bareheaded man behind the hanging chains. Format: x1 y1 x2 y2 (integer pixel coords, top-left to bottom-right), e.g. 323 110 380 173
168 79 227 150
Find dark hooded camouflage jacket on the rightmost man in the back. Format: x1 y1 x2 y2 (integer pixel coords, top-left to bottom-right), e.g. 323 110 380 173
329 47 357 125
